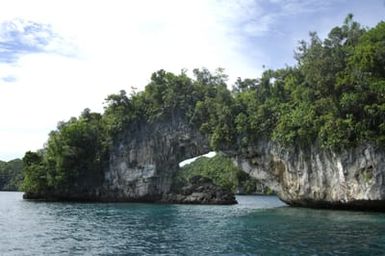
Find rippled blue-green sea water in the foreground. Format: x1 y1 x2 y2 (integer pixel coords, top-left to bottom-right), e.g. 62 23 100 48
0 192 385 255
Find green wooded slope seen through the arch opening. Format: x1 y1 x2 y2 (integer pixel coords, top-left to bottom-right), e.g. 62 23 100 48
175 154 263 194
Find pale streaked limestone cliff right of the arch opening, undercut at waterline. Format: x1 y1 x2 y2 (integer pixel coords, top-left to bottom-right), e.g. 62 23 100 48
233 141 385 211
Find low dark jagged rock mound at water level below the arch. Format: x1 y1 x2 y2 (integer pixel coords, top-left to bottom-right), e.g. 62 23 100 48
161 176 237 204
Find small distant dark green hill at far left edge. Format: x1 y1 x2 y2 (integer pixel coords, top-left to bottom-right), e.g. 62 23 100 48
0 159 23 191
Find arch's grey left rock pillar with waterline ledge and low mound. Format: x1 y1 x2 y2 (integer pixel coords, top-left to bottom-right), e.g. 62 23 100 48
23 115 236 204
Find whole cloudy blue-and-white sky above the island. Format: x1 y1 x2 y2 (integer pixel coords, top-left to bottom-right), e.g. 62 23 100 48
0 0 385 160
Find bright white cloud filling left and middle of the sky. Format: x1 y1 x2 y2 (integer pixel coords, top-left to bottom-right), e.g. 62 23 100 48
0 0 259 159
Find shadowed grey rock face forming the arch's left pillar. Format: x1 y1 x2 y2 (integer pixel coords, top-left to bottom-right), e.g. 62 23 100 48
101 118 209 201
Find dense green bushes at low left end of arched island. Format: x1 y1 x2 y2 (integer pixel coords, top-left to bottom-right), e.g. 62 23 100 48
23 109 106 192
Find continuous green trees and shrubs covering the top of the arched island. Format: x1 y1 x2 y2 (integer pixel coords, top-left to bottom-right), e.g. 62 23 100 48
23 15 385 195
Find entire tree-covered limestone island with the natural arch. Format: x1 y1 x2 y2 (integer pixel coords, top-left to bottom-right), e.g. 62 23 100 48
23 15 385 210
